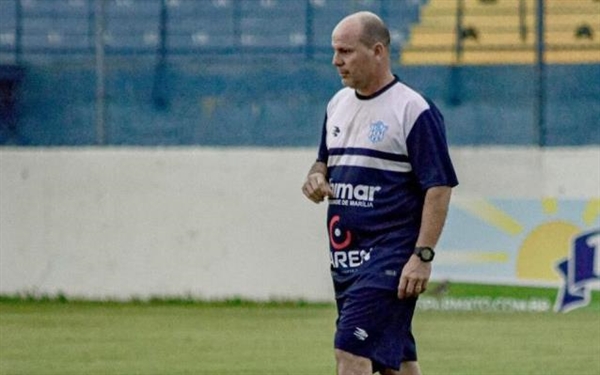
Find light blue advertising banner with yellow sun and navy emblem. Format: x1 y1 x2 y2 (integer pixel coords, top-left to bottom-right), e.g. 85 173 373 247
433 197 600 312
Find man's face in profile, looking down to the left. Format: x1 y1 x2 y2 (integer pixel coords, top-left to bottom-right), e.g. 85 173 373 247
331 20 374 93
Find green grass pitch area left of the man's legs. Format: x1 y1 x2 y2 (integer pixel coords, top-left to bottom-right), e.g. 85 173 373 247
0 302 334 375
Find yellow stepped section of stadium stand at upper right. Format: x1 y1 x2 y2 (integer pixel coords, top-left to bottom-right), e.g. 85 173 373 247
401 0 600 65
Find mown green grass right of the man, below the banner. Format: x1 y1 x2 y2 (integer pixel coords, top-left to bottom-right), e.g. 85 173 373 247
415 311 600 375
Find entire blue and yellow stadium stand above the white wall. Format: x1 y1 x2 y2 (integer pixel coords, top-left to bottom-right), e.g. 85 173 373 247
0 0 600 147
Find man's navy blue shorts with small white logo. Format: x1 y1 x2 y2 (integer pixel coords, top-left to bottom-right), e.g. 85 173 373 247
335 288 417 372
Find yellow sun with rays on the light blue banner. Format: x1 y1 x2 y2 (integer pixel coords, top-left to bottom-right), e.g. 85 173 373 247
454 198 600 282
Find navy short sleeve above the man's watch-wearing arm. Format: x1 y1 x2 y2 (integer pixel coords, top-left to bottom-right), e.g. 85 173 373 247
406 103 458 191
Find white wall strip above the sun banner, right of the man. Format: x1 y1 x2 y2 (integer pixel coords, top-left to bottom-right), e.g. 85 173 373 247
452 147 600 199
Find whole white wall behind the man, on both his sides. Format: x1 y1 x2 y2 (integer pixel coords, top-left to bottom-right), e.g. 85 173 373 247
0 148 600 300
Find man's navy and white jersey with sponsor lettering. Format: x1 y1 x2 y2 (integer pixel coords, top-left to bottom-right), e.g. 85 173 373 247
317 77 458 294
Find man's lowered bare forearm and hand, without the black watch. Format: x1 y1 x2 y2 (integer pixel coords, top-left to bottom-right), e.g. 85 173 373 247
398 186 452 298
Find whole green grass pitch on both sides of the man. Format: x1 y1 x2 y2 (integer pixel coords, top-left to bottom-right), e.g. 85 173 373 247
0 286 600 375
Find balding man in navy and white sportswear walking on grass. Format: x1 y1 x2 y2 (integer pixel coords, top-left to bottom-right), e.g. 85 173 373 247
302 12 458 375
